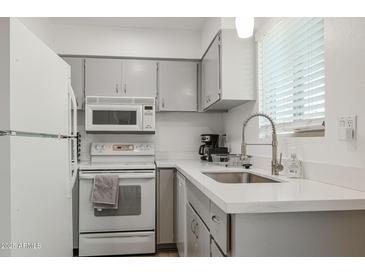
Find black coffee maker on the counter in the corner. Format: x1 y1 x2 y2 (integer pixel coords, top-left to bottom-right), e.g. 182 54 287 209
199 134 228 162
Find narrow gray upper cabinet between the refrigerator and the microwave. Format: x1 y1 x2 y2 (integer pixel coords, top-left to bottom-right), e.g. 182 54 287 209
63 57 85 109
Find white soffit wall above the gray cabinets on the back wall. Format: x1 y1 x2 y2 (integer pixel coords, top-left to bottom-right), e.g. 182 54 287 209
54 24 201 59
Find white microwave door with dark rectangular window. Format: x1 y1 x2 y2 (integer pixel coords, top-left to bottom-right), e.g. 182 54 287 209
85 105 143 132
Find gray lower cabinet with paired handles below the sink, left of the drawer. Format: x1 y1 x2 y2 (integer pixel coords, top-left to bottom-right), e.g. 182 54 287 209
186 201 210 257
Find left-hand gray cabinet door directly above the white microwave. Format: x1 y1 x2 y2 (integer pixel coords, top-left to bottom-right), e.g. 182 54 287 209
85 58 124 96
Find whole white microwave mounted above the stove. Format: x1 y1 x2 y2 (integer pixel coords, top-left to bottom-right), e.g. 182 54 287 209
85 96 155 134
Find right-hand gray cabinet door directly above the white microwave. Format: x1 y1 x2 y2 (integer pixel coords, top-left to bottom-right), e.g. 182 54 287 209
122 60 157 98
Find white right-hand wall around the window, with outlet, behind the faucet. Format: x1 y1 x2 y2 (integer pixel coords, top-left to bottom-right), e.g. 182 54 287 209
224 18 365 189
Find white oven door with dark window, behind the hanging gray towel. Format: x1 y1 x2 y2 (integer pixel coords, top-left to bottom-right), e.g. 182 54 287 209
79 170 155 233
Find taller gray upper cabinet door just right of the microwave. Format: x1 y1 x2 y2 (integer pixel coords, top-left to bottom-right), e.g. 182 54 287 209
158 61 198 111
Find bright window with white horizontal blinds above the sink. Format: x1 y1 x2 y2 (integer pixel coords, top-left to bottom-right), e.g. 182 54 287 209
258 18 325 136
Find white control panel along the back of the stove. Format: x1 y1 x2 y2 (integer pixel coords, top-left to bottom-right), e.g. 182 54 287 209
90 143 155 155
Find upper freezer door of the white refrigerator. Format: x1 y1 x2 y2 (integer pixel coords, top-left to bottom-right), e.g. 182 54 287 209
8 18 71 135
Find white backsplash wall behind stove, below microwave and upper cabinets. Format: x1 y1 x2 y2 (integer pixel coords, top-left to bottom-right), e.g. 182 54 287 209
78 111 223 161
